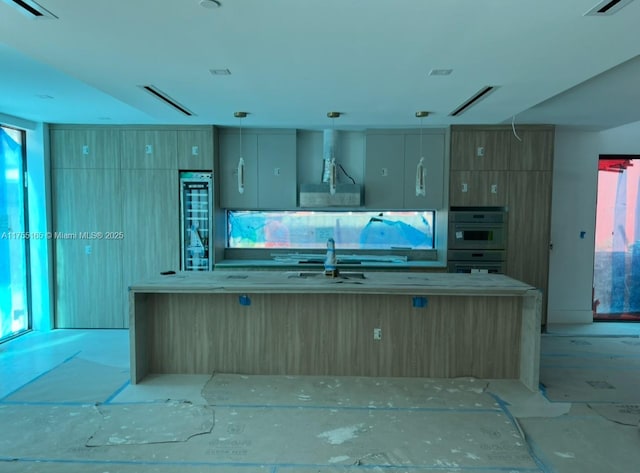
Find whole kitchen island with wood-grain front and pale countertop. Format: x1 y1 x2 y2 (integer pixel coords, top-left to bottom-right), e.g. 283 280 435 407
129 271 541 391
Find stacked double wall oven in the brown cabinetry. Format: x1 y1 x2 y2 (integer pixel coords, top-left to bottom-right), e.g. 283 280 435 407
447 208 507 274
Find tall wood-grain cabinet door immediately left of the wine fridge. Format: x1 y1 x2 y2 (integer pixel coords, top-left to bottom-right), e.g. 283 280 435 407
121 170 180 326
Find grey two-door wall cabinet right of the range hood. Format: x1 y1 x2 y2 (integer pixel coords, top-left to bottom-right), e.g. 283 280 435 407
364 130 445 209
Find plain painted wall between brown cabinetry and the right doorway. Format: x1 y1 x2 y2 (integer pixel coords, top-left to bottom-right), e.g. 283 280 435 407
547 122 640 324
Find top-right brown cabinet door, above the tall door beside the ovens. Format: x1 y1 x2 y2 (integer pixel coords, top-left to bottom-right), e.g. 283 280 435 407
509 128 554 171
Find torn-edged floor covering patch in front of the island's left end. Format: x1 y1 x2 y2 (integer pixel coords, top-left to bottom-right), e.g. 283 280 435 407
86 401 214 447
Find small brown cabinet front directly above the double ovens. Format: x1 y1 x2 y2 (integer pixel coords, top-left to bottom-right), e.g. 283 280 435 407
449 171 508 207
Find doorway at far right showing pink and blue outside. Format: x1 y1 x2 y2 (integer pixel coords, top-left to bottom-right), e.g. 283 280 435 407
593 155 640 322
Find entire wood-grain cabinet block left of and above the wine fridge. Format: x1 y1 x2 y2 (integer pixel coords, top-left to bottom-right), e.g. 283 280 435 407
50 125 214 328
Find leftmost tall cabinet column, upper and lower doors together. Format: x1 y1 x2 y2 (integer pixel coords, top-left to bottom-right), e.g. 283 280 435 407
50 127 125 328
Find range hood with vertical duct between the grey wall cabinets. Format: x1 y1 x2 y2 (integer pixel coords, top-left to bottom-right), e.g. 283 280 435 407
298 129 363 208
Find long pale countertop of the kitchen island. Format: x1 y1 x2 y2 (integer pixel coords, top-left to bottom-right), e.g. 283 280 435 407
129 270 535 296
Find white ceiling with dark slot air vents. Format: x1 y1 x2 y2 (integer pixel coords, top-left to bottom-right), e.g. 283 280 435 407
0 0 640 129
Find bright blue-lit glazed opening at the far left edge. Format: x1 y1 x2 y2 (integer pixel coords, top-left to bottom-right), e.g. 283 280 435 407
0 126 31 341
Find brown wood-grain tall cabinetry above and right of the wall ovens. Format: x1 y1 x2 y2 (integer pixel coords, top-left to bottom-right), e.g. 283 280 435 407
449 125 554 324
